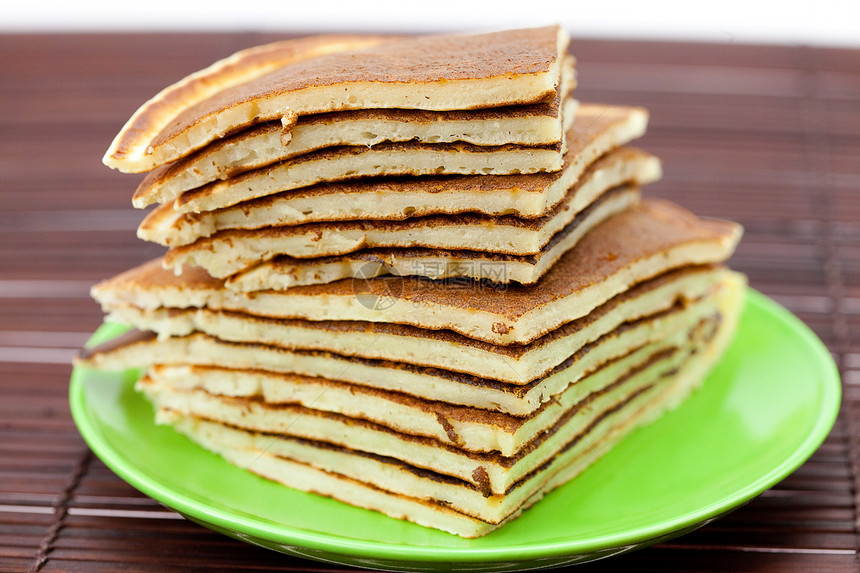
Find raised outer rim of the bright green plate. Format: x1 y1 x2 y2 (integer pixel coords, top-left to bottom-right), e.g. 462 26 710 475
69 288 842 565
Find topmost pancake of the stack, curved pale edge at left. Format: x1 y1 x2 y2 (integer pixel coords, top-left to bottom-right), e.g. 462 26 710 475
104 26 568 172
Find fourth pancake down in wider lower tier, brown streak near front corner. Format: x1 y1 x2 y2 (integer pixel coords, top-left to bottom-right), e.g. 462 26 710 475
147 336 686 456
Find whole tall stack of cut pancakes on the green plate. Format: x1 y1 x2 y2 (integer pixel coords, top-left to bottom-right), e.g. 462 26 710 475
79 27 744 537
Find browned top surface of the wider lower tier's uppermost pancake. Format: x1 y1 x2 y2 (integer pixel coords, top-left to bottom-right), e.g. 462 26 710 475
94 200 740 320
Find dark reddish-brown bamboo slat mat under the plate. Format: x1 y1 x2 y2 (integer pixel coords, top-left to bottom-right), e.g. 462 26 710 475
0 34 860 572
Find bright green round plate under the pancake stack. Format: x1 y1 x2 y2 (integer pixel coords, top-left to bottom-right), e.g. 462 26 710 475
71 291 840 571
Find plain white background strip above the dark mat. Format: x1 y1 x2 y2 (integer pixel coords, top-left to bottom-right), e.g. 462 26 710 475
5 0 860 47
